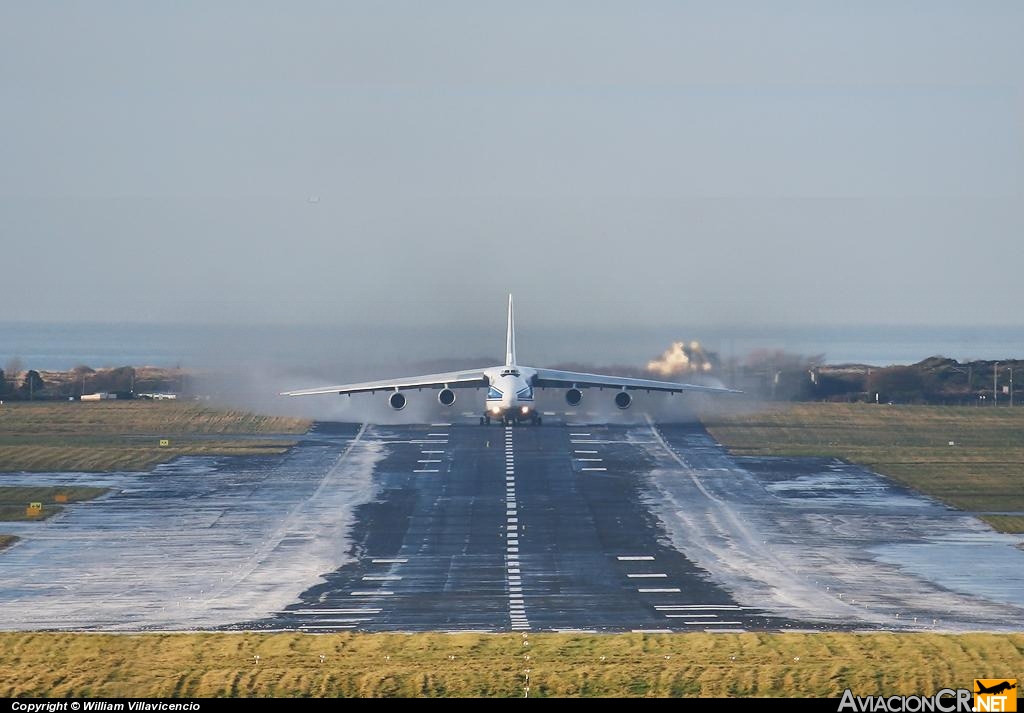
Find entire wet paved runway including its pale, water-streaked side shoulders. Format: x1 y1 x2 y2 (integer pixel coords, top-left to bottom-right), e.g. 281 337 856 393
0 423 1024 632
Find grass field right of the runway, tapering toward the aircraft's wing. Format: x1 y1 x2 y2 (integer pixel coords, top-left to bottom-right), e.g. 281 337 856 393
706 404 1024 533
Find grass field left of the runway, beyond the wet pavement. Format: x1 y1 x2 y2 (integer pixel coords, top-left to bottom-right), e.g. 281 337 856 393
0 402 309 472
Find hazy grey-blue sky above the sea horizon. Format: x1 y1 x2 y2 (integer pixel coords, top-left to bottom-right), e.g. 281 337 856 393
0 0 1024 326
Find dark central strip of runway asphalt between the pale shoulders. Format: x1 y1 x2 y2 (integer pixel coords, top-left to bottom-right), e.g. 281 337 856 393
243 425 796 631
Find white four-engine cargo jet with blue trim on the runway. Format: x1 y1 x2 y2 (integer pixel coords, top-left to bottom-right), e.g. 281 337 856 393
282 295 738 425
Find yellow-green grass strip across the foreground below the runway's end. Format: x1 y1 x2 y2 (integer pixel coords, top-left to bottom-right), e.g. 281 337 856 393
0 633 1024 698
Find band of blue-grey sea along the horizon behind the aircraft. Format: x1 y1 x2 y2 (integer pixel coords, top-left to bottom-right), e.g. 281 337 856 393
0 322 1024 371
